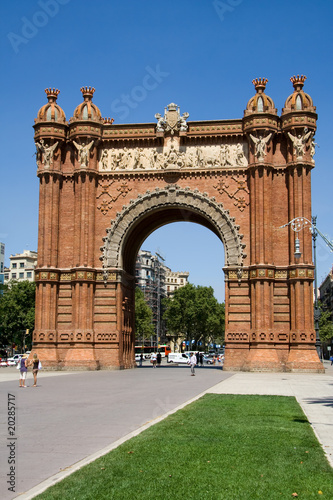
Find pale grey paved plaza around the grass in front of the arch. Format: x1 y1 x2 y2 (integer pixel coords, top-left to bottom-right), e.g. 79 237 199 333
0 362 333 500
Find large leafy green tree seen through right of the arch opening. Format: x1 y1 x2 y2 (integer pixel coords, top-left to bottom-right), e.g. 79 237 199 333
163 283 225 350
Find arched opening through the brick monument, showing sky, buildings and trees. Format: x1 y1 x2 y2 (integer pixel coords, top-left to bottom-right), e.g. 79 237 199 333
135 222 225 360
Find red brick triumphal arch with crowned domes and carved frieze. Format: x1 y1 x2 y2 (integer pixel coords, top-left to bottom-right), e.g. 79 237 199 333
33 76 322 371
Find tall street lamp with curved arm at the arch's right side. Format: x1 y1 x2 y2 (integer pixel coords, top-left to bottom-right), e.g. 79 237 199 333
280 216 333 359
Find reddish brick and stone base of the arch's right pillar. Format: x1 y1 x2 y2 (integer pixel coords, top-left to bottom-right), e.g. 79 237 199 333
223 344 325 373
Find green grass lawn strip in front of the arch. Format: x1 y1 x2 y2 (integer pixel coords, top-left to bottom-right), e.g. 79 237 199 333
36 394 333 500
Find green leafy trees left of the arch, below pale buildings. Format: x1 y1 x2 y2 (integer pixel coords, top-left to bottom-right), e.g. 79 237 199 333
0 281 36 345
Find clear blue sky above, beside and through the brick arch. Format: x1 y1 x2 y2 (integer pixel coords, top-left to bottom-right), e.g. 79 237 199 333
0 0 333 301
